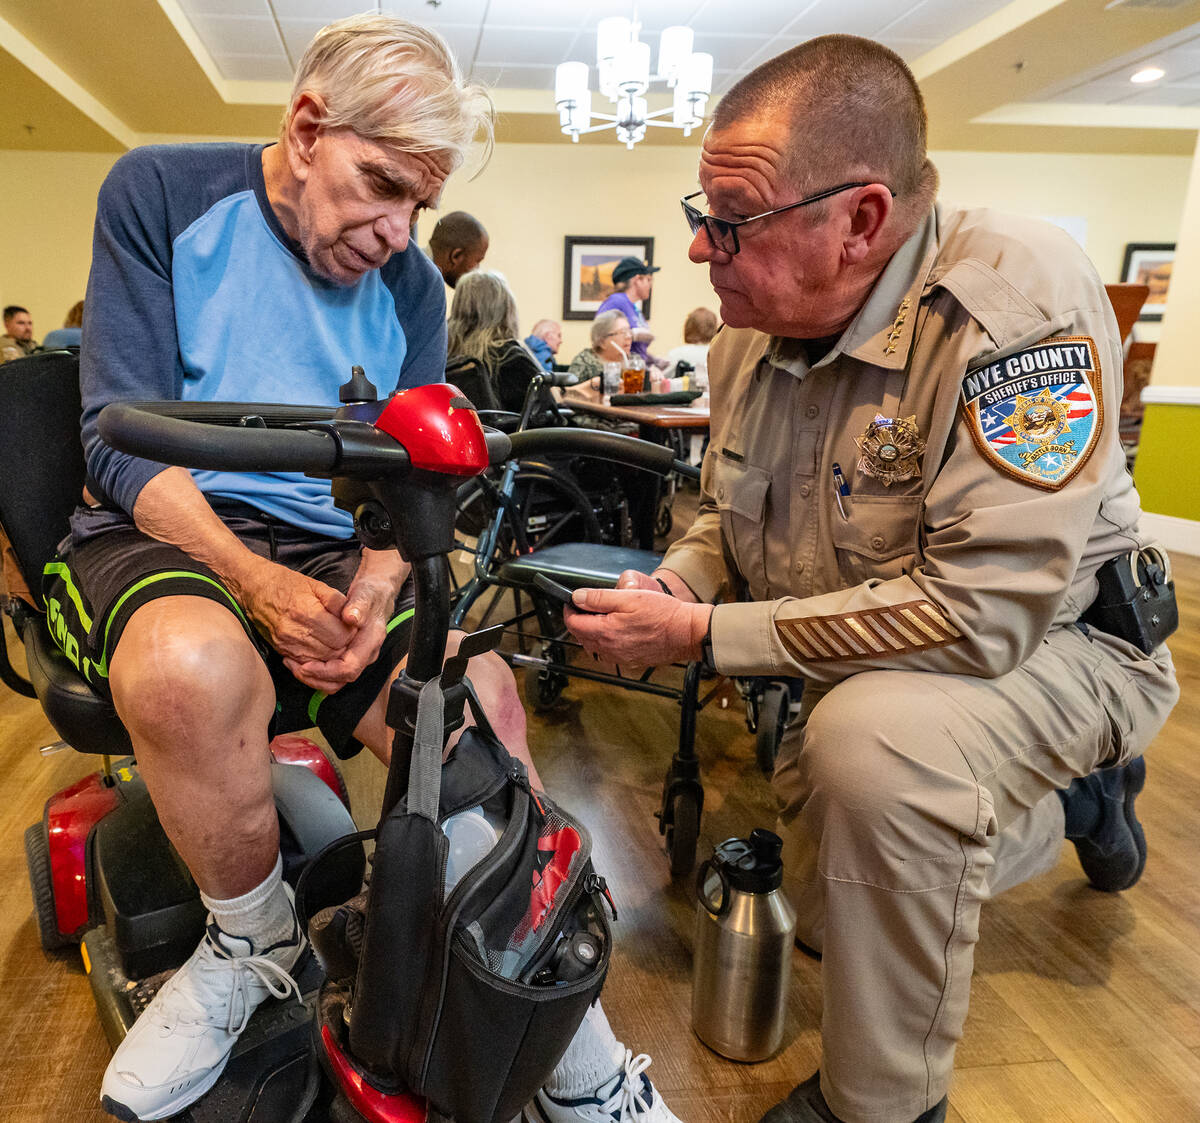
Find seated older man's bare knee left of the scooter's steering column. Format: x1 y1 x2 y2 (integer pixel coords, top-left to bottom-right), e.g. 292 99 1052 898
109 597 274 745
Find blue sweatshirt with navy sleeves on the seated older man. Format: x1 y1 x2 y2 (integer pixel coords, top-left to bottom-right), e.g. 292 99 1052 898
80 144 446 538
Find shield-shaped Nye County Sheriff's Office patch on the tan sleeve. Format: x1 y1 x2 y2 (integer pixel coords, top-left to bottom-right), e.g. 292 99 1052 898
962 336 1104 491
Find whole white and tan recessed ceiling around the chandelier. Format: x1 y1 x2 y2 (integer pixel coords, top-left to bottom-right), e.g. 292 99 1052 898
0 0 1200 155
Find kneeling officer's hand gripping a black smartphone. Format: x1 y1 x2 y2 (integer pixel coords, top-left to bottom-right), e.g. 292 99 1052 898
563 592 713 669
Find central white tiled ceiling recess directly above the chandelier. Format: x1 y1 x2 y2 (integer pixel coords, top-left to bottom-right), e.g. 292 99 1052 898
180 0 1022 92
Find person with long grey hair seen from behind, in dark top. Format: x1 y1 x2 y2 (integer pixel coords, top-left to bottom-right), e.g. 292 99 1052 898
446 270 542 413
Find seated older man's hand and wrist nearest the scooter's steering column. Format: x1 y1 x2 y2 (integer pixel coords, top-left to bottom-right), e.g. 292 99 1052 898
283 550 409 693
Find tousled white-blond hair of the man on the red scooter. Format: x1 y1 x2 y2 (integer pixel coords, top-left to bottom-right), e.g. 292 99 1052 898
283 13 494 169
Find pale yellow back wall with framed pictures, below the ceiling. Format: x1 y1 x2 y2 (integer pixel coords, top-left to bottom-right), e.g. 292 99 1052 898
0 138 1200 359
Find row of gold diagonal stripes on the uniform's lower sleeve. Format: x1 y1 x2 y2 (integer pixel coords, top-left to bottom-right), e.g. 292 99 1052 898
775 600 962 662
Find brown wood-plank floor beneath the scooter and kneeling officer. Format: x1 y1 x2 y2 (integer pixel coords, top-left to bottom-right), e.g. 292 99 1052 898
0 527 1200 1123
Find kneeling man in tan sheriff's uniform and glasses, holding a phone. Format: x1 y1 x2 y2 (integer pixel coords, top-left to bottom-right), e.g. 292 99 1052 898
568 36 1178 1123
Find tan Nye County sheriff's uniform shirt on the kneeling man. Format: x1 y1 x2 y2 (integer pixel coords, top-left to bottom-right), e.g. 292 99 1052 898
664 205 1145 684
